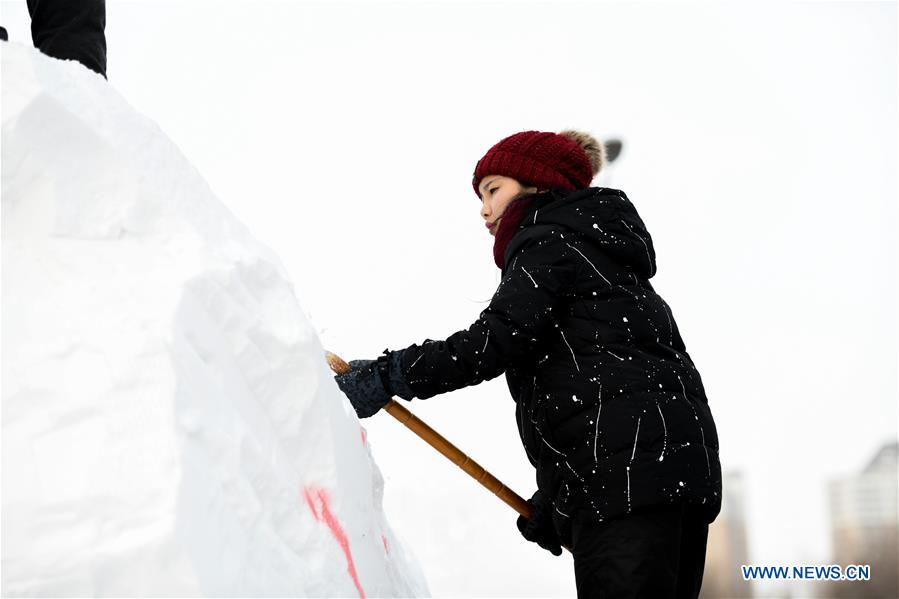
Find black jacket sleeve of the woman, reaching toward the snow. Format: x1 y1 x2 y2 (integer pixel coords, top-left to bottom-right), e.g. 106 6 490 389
391 226 579 399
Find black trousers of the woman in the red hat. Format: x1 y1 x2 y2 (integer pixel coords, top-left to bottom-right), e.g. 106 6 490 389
560 503 709 599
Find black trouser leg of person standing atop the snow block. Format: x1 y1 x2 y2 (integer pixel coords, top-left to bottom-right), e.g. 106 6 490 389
28 0 106 78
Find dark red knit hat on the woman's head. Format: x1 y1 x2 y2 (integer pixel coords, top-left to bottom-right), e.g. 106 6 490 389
471 131 601 197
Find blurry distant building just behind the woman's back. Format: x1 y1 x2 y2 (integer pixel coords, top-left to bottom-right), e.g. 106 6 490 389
699 472 752 599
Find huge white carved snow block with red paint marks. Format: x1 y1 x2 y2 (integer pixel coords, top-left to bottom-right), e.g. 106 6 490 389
0 43 429 597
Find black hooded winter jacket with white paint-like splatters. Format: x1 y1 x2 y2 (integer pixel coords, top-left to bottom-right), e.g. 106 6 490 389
391 187 721 529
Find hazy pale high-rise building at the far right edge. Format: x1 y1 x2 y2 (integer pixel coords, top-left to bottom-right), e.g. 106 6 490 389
825 442 899 597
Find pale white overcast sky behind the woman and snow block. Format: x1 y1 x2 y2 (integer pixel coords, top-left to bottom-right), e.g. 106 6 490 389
0 0 897 596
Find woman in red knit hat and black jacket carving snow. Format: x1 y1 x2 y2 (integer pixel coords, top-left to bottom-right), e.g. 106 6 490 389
335 131 721 597
